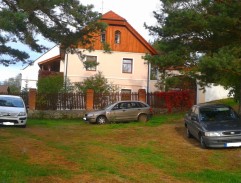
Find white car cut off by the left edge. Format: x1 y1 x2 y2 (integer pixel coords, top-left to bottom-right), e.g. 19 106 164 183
0 95 27 128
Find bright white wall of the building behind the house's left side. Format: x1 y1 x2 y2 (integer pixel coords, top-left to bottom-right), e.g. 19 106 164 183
21 45 59 89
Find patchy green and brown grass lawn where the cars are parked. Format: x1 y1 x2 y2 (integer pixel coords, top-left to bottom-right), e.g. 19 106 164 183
0 100 241 183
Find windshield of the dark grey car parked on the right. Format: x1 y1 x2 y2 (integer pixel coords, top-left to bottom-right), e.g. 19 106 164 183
200 107 238 121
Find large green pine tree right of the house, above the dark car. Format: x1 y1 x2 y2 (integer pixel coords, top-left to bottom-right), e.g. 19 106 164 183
146 0 241 111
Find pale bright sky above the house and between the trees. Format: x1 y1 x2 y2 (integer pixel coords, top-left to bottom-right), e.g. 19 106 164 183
0 0 160 81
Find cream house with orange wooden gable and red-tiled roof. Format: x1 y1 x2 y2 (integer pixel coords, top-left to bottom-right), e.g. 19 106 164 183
38 11 157 92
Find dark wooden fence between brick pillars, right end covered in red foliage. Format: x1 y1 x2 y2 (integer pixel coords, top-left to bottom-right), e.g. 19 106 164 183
0 90 196 112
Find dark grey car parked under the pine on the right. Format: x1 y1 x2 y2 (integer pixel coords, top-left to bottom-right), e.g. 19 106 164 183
184 104 241 148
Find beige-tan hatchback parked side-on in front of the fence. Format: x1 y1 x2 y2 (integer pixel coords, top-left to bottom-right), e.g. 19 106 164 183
83 101 152 124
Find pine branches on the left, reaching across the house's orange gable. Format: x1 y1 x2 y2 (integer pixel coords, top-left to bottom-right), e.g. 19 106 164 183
0 0 104 66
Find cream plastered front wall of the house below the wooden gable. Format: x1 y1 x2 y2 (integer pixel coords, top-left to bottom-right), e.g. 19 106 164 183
64 50 148 92
